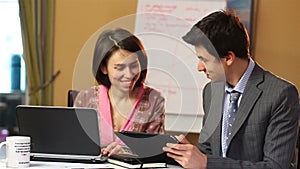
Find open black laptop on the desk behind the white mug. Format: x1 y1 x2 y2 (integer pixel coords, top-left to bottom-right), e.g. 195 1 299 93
16 105 106 163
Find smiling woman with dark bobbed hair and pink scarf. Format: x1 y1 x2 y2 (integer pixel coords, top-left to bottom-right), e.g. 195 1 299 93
74 29 165 155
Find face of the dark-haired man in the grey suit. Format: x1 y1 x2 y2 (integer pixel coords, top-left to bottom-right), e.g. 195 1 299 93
195 45 225 82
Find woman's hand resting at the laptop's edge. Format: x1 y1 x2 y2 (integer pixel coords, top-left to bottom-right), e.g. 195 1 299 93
101 142 132 157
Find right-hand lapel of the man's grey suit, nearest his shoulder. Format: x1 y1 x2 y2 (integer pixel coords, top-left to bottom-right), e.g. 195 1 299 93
229 64 264 144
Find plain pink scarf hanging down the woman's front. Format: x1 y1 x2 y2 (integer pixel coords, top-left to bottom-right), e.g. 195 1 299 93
99 85 144 145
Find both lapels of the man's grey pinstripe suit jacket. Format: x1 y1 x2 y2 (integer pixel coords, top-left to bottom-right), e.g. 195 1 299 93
199 64 264 154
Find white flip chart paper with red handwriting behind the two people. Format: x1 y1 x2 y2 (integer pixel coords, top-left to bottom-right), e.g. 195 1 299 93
135 0 226 114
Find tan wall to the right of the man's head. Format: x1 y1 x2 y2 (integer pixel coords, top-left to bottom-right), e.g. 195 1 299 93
254 0 300 91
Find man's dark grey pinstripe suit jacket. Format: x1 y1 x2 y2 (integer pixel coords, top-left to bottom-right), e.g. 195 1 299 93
199 64 300 169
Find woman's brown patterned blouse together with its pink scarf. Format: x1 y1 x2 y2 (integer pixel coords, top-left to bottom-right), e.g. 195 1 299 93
74 85 165 145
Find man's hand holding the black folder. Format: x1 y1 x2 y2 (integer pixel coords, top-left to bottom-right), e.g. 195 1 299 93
163 135 207 169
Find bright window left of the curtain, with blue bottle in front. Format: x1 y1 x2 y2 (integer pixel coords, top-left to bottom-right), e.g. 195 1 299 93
0 0 26 93
